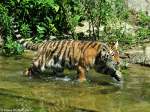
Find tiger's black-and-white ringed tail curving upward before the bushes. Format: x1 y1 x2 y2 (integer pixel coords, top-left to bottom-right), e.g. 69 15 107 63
12 21 39 51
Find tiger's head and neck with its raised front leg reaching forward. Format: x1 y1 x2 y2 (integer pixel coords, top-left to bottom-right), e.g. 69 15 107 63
95 42 122 82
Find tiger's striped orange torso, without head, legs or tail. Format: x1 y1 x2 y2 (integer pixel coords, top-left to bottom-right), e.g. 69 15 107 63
35 40 101 70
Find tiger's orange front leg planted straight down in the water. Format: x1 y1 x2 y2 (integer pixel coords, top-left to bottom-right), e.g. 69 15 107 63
77 66 86 82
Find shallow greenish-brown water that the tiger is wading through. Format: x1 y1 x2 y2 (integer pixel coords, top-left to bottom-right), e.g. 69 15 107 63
0 52 150 112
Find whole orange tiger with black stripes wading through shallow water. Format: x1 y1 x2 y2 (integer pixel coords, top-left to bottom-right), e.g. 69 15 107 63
14 20 122 82
